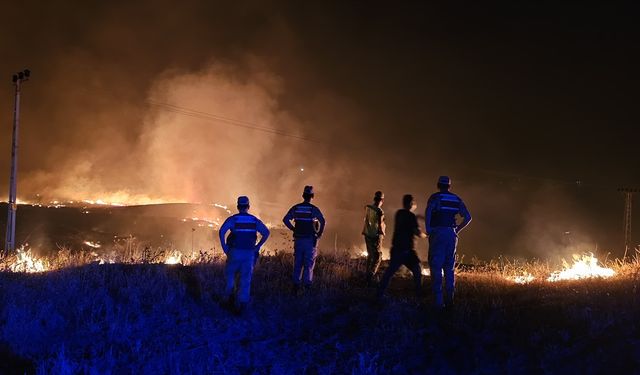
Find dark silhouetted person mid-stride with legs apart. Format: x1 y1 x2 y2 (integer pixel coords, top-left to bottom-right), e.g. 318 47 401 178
378 194 426 297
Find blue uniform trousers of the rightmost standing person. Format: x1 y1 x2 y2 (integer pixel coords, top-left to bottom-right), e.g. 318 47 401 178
429 227 458 307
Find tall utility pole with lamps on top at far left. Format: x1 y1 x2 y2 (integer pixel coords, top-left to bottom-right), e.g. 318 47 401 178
3 69 31 256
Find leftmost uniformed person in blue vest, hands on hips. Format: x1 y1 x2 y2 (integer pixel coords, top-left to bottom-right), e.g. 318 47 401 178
219 196 269 312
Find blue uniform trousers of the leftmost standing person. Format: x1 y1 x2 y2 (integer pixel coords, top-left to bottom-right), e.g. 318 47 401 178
224 249 255 303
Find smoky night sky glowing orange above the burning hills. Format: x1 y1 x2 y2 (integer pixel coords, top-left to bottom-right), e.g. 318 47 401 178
0 1 640 258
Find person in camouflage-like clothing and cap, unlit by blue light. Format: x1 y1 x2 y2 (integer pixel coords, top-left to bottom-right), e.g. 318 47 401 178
362 191 386 285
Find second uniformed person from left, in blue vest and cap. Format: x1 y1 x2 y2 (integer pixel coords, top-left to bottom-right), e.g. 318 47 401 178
282 186 325 293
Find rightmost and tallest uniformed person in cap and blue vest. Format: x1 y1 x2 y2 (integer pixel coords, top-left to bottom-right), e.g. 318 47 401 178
424 176 471 308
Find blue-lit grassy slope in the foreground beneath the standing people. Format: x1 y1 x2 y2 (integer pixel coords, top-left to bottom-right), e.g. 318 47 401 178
0 255 640 374
